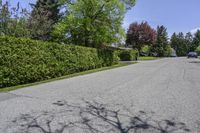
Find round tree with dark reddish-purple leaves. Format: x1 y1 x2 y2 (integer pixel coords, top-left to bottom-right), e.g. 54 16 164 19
126 22 156 51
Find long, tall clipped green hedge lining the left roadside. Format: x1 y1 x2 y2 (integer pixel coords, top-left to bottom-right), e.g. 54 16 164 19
0 37 118 88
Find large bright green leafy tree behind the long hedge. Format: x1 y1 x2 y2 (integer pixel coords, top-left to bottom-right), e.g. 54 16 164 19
53 0 135 47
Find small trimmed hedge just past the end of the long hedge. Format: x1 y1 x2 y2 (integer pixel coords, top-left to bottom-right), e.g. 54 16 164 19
119 50 138 61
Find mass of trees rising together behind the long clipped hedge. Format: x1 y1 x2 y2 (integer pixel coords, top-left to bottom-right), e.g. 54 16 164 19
0 0 135 47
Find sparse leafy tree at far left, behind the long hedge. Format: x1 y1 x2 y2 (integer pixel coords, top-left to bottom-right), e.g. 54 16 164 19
0 1 29 37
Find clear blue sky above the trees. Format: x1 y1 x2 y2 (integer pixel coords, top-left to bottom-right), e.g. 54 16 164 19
3 0 200 35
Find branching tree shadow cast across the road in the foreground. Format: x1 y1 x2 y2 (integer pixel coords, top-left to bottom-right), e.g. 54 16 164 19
5 101 190 133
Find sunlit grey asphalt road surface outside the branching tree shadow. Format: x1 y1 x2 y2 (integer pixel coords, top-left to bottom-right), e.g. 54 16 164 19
0 58 200 133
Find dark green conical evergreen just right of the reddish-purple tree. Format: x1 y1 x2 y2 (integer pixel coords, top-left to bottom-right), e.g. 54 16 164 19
152 25 170 57
